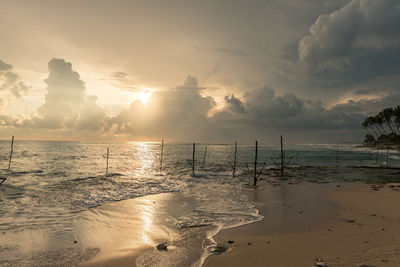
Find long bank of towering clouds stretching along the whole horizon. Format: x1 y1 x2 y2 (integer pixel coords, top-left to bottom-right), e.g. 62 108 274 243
0 59 394 141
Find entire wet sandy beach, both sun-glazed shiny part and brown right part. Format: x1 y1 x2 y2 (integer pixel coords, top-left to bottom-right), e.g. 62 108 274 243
0 171 400 267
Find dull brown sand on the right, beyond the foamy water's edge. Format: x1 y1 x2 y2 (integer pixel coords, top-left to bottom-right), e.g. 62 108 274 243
205 182 400 267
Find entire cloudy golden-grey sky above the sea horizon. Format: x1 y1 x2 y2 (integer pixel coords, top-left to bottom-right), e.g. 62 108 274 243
0 0 400 144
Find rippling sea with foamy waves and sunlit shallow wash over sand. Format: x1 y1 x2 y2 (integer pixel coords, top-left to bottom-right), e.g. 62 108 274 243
0 140 400 266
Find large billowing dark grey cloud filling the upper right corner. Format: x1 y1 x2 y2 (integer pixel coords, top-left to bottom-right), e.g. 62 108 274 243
298 0 400 82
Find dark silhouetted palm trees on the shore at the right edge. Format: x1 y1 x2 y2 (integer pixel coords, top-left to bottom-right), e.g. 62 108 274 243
361 105 400 147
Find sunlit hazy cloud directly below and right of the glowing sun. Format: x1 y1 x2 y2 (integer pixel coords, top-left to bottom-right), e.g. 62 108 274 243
109 75 215 140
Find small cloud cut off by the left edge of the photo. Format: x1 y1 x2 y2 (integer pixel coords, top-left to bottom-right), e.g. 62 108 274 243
0 60 29 98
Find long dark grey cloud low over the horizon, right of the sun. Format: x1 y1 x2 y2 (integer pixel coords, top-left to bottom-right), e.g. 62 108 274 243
216 87 363 130
